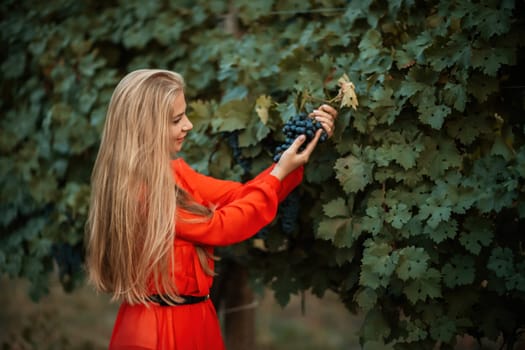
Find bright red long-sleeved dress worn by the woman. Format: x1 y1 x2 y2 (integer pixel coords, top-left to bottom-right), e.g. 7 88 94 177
109 159 303 350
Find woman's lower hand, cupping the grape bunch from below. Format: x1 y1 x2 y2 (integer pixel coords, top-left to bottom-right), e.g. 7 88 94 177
270 129 323 180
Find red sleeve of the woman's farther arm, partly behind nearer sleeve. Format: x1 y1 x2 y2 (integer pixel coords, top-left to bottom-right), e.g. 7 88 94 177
172 158 304 206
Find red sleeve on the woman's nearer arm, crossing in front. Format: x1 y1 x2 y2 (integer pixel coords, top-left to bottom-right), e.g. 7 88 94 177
176 174 282 246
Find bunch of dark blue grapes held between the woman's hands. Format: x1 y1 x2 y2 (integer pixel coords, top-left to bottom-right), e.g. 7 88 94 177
273 113 328 162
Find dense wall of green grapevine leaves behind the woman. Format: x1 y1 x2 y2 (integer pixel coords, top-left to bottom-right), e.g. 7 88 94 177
0 0 525 349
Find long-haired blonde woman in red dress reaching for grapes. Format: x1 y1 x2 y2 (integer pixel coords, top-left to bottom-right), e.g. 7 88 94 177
86 70 337 350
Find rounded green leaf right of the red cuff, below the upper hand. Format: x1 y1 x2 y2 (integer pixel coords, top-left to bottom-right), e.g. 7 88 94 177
334 155 373 193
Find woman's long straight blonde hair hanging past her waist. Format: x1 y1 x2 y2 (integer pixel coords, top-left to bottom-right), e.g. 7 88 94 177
86 69 213 304
